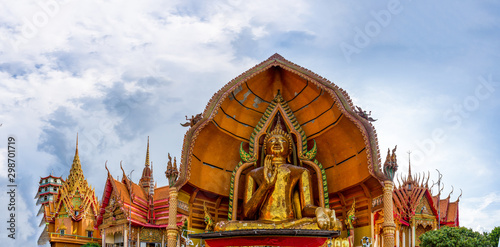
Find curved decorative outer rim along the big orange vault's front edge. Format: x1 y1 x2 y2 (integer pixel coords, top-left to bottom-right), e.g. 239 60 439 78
176 53 386 187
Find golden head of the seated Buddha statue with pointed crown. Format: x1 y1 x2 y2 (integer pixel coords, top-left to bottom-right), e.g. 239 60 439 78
264 122 292 157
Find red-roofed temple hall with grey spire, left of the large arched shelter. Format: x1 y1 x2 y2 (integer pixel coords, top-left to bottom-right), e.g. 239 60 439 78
96 139 187 247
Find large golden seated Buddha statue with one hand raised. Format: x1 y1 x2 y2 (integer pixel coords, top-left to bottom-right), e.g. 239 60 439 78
215 121 341 231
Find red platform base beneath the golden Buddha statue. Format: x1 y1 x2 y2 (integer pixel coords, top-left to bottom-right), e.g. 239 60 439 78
189 229 340 247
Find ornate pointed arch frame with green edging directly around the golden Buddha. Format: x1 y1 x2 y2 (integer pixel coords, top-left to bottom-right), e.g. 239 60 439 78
228 90 329 220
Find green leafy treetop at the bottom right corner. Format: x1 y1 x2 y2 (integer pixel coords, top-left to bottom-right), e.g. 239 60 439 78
419 226 490 247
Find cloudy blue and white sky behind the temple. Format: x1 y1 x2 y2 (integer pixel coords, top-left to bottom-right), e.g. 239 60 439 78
0 0 500 246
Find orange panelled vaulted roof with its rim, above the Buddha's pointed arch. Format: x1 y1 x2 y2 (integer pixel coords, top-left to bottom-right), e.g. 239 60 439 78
178 54 383 199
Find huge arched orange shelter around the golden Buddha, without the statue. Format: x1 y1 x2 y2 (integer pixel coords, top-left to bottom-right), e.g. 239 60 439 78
168 54 397 247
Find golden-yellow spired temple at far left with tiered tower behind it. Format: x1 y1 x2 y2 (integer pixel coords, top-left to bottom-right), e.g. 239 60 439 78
35 137 100 247
